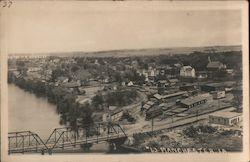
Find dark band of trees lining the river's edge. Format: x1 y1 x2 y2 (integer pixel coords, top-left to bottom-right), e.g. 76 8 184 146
8 74 93 130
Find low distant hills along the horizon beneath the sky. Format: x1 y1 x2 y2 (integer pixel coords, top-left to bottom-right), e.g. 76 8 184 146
10 45 242 57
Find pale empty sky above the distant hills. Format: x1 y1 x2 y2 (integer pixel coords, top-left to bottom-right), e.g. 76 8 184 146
4 3 241 53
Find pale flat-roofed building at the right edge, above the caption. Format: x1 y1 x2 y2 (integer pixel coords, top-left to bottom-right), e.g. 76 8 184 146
209 112 242 126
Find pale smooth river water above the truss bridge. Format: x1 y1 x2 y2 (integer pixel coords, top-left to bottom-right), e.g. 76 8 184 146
8 84 62 139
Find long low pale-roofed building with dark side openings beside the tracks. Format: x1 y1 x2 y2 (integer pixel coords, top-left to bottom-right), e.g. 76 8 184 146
180 95 208 108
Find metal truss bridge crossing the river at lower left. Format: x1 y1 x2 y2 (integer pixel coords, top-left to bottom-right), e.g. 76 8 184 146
8 123 127 154
